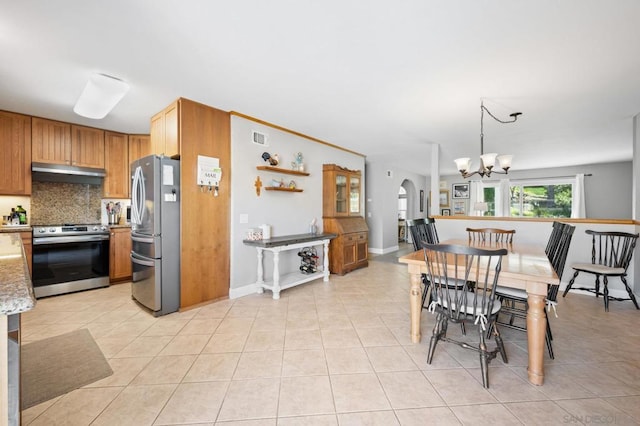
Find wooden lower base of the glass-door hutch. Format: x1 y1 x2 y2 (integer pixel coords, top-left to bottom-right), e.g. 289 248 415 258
323 217 369 275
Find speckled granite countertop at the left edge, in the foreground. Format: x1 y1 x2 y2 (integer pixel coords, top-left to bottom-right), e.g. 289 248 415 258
0 231 36 315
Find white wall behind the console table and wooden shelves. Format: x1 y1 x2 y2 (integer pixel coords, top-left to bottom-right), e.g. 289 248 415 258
231 115 368 298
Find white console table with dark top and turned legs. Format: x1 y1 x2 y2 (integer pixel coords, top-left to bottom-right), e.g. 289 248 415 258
243 234 337 299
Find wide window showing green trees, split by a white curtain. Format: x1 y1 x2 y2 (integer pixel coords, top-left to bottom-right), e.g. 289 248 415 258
483 179 575 217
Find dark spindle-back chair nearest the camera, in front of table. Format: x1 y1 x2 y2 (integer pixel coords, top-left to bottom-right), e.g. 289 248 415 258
424 244 508 388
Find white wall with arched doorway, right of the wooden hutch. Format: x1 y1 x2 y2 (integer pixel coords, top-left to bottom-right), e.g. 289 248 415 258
365 162 429 254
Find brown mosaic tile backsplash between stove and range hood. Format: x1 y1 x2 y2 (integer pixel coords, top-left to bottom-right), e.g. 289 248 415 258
28 181 102 225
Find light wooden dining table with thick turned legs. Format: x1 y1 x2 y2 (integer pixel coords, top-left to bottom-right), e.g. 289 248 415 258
398 239 558 385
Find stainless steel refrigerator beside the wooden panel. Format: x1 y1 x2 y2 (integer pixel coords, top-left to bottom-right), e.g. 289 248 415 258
131 155 181 316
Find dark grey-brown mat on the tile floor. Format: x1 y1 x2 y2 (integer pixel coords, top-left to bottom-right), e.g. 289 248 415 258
20 328 113 410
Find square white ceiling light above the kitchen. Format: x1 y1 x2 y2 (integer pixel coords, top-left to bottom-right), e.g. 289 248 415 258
73 74 129 120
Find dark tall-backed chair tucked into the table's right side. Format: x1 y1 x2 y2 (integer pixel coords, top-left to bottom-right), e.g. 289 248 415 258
496 222 576 359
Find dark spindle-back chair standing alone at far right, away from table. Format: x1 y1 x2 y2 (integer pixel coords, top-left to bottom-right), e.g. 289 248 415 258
562 230 640 312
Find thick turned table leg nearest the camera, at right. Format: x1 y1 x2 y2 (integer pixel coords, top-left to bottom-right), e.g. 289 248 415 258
527 293 547 385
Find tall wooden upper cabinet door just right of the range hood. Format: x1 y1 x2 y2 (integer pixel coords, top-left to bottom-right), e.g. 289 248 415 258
103 132 130 198
